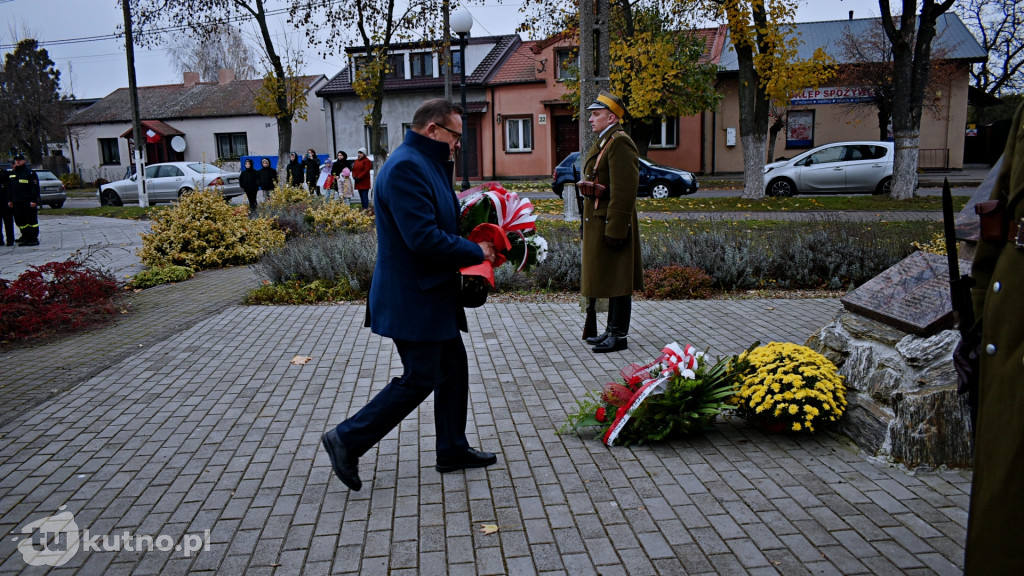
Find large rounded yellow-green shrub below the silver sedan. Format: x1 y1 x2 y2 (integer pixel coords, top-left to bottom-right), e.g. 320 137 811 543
138 190 285 270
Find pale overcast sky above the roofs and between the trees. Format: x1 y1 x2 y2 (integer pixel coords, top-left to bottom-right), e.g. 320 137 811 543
0 0 880 98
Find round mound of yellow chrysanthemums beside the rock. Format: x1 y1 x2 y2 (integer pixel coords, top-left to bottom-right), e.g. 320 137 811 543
732 342 846 431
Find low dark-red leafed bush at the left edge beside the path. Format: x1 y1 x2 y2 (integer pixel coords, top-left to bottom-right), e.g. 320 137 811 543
0 260 118 341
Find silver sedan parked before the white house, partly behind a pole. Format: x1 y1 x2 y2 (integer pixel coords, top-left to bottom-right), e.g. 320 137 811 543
96 162 242 206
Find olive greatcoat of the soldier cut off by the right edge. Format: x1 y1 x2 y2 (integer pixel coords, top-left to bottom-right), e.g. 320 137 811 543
965 99 1024 576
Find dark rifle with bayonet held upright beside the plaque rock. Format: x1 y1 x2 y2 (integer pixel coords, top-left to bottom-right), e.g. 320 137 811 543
942 178 981 436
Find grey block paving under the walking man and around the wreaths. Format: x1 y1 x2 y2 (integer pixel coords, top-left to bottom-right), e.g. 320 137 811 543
0 289 970 576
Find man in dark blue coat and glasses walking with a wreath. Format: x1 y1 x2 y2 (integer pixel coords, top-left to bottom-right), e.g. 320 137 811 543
322 98 498 491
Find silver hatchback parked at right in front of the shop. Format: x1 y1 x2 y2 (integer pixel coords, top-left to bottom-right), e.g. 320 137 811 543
764 141 893 196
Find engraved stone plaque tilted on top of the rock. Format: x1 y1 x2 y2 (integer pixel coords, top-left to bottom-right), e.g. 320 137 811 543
840 252 971 336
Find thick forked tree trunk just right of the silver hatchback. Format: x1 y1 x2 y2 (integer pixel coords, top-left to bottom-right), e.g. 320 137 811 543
879 0 955 200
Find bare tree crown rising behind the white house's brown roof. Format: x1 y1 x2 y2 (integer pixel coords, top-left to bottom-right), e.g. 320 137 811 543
167 27 260 82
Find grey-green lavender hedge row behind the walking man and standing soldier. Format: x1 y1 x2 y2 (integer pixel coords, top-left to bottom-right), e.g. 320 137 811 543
245 217 941 298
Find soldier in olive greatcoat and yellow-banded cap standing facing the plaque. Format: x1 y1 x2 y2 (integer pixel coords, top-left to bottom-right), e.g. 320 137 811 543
578 90 643 353
